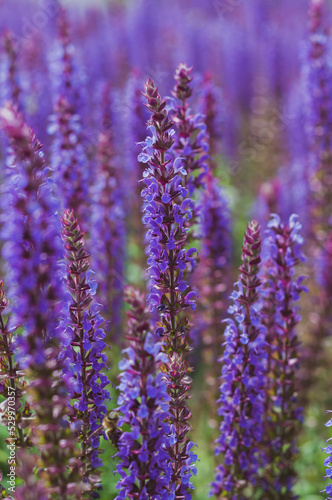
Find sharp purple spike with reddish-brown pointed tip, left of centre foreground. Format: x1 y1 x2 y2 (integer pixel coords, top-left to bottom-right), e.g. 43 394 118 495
62 210 110 487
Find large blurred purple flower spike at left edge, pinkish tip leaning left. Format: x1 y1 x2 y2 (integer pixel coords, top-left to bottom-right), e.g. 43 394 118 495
1 104 63 367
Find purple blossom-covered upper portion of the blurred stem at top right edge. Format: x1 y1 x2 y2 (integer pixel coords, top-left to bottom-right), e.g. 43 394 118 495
306 0 332 242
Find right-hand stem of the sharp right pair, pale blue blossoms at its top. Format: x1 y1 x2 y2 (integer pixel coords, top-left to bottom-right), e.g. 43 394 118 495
261 215 306 499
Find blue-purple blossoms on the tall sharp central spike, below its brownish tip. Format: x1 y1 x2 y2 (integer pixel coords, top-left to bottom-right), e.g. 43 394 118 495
138 80 197 320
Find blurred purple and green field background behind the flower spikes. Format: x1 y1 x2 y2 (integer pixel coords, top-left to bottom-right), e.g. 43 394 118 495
0 0 332 500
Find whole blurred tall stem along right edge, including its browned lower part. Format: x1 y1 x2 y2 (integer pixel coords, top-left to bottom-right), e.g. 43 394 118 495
301 0 332 410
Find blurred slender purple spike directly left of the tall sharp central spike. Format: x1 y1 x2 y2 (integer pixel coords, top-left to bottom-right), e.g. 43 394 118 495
91 86 126 340
